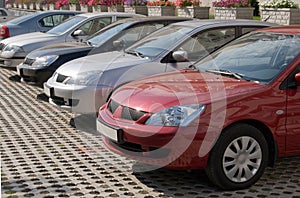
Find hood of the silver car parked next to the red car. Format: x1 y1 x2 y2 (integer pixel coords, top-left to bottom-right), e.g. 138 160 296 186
56 51 151 77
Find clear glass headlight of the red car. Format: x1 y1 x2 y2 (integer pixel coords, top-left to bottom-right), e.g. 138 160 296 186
146 104 205 126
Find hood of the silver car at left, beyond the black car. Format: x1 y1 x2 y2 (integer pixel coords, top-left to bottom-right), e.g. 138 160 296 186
1 32 60 51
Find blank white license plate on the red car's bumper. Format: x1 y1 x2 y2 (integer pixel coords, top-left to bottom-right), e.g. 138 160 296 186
97 118 123 143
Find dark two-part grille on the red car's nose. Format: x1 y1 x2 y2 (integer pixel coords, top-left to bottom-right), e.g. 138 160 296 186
108 100 147 121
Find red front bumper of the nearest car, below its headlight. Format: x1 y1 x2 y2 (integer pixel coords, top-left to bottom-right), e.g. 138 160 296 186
97 108 215 169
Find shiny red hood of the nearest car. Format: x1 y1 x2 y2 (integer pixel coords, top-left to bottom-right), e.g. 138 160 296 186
111 70 266 113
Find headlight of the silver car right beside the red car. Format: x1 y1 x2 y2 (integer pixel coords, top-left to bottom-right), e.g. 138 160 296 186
66 71 103 86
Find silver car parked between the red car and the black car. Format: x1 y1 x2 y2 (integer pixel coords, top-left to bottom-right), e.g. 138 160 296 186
44 20 274 113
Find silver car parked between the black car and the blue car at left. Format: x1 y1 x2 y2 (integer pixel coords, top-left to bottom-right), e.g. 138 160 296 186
0 12 143 68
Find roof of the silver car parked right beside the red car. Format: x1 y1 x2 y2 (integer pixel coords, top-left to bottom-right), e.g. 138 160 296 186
173 19 278 28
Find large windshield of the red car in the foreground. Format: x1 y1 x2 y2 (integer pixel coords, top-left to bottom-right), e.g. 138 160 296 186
195 32 300 84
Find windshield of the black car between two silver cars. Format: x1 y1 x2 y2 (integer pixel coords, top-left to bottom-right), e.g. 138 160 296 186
87 22 132 46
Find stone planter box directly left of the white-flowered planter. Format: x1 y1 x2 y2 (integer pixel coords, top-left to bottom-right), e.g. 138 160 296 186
215 7 254 20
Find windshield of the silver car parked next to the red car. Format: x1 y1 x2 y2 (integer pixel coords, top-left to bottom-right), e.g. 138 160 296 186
126 25 194 59
